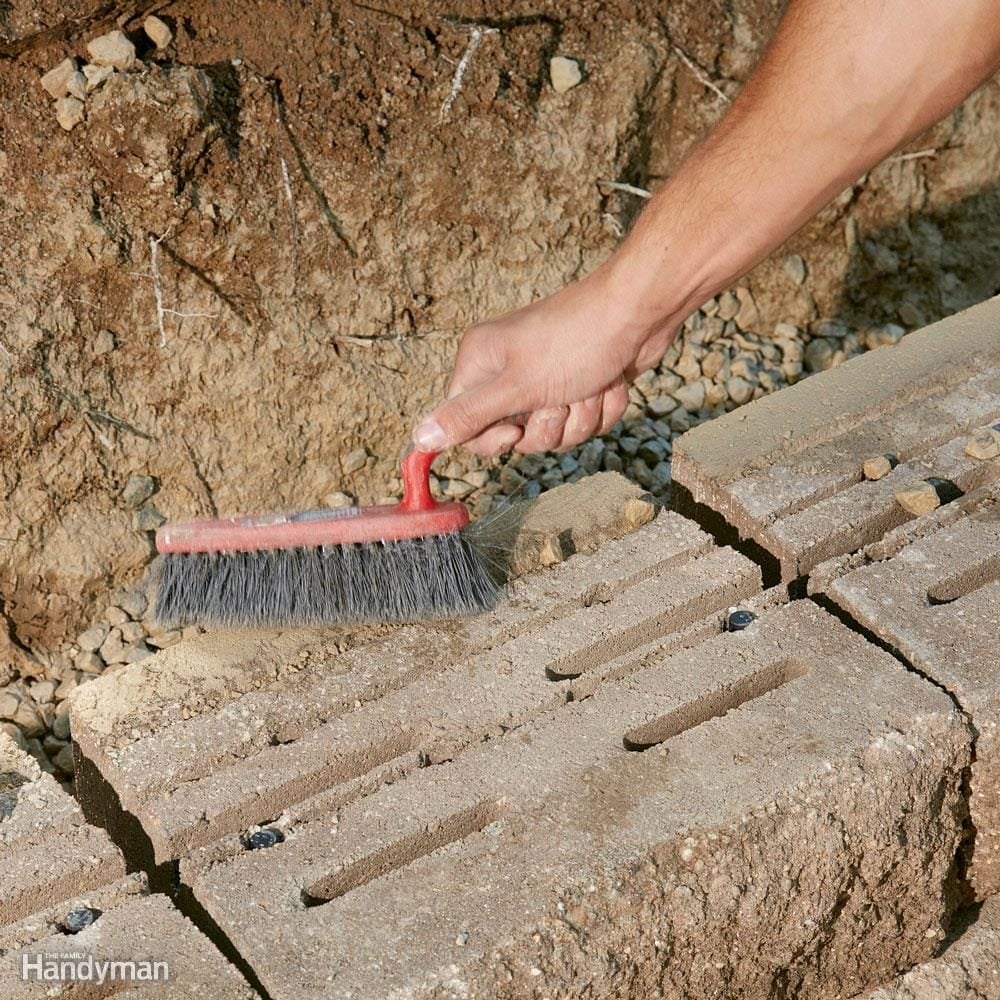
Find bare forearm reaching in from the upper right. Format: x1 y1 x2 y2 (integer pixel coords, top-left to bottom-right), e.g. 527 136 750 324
601 0 1000 334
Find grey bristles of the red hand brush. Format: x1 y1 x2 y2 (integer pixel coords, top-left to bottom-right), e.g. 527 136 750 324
156 532 501 627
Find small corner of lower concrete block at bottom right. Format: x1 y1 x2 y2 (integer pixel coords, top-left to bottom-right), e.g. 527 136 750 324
855 897 1000 1000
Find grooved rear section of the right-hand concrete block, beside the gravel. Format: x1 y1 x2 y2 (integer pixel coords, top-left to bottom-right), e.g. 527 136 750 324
672 298 1000 580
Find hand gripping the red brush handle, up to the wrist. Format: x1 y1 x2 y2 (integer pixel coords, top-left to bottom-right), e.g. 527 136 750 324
413 267 677 455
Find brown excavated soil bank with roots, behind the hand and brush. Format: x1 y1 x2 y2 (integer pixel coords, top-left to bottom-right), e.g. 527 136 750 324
0 0 1000 671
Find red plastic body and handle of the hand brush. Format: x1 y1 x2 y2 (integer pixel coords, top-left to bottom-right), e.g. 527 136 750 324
156 450 469 553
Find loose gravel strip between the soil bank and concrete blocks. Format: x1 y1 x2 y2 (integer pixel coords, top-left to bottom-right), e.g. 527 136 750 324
0 292 906 782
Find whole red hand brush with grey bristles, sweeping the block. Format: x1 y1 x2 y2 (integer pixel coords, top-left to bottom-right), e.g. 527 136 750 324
156 451 500 627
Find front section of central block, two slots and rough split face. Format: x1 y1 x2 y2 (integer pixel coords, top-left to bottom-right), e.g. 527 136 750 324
180 601 971 1000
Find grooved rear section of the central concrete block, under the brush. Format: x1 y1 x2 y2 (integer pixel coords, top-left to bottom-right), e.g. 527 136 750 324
71 513 760 863
